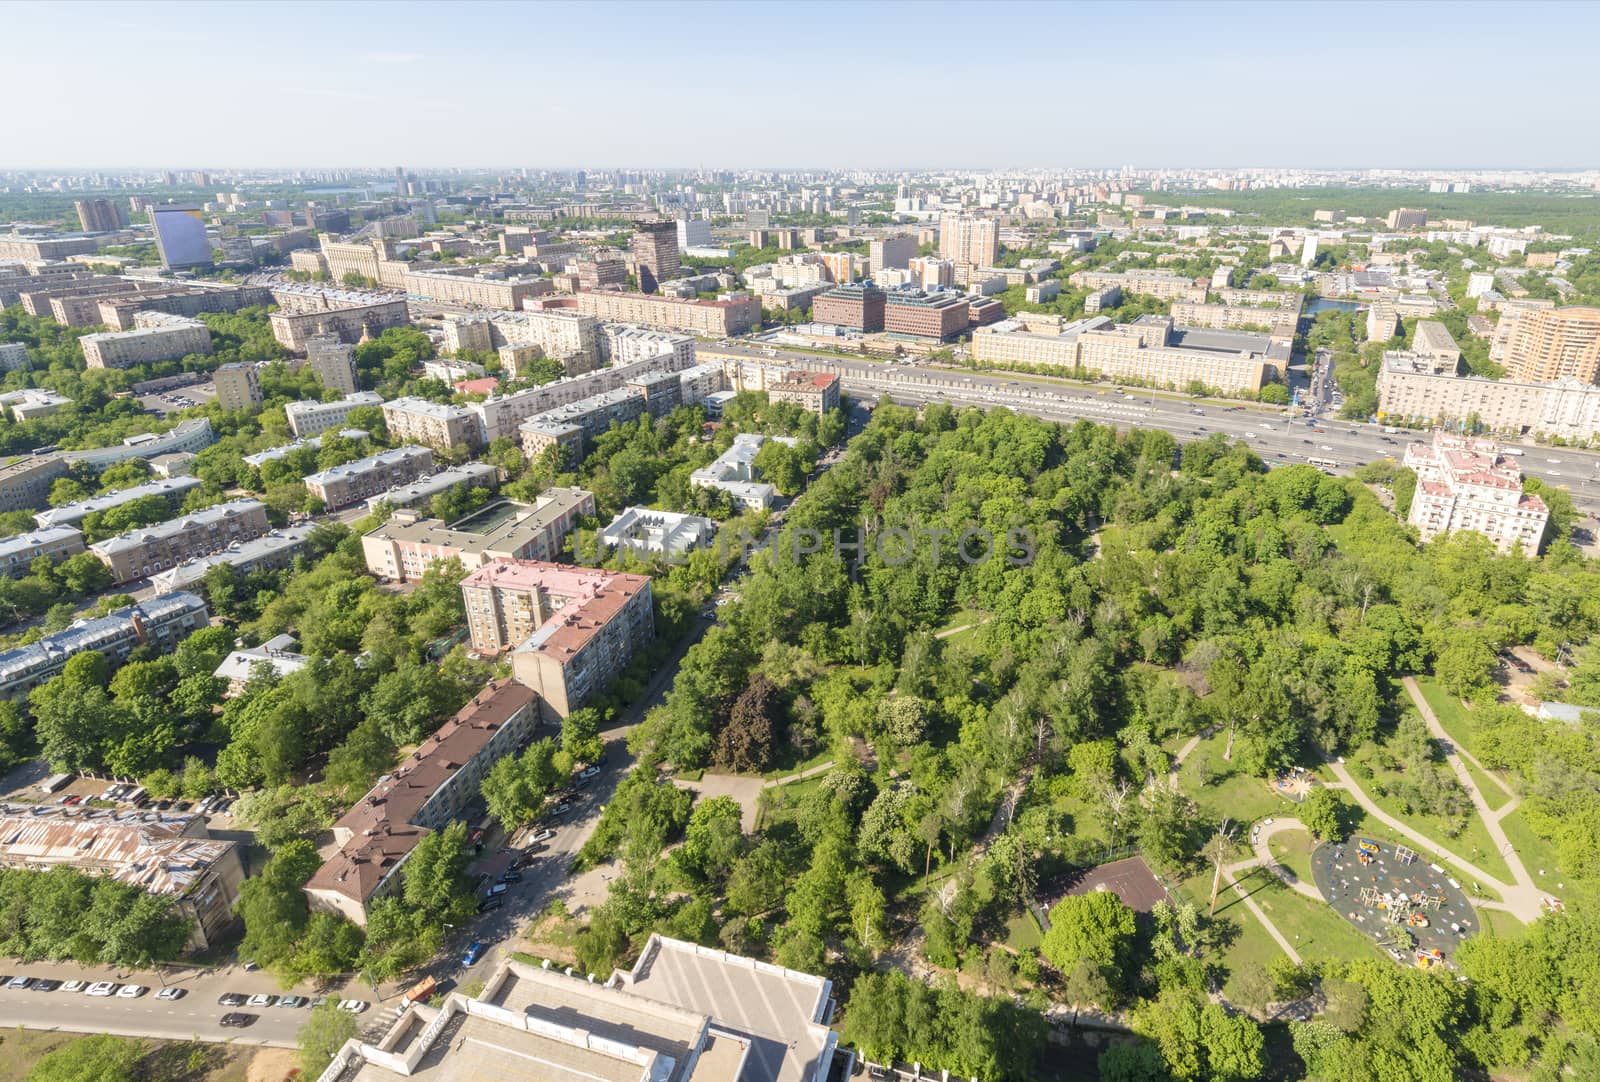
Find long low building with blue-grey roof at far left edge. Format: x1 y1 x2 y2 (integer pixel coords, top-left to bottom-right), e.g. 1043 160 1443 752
0 591 210 699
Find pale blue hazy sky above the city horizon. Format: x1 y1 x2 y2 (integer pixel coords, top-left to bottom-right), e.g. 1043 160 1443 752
12 0 1600 170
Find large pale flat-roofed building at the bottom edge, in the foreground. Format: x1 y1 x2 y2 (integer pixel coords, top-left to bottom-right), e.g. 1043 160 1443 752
318 935 838 1082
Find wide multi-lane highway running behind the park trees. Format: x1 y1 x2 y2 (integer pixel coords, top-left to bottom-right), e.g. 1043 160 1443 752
698 344 1600 514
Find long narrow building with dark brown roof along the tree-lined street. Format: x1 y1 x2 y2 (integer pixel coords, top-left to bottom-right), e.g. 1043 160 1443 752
306 680 539 927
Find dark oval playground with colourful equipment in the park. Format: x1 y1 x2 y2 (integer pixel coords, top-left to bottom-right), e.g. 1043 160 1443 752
1310 837 1478 967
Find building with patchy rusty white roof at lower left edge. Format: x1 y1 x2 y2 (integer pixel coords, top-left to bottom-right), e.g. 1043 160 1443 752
0 803 245 951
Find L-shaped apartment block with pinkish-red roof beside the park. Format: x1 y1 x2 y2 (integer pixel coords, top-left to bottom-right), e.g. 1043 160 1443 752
461 560 654 720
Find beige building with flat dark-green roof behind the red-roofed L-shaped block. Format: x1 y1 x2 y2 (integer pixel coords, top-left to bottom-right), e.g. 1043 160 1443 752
362 488 595 583
